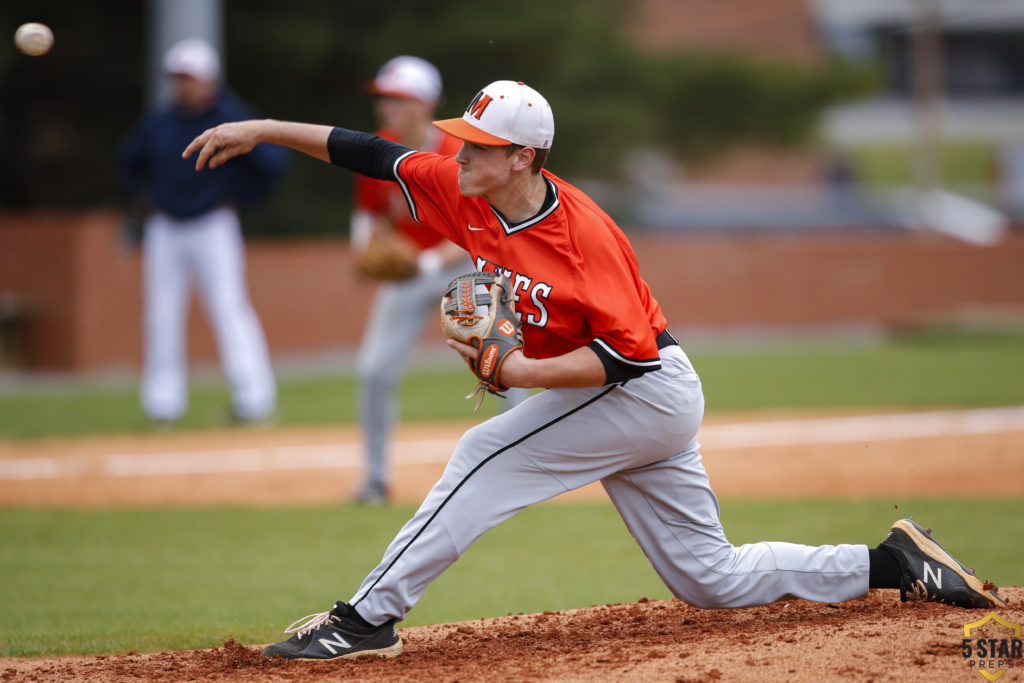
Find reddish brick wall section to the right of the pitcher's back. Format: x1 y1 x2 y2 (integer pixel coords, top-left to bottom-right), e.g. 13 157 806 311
634 231 1024 329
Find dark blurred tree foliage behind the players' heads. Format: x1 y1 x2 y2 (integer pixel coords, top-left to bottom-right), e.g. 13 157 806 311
0 0 872 233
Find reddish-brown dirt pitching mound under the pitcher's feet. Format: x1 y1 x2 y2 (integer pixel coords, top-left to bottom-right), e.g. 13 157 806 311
0 588 1024 683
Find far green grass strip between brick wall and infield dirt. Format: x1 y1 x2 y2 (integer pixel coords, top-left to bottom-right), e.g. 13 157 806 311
0 331 1024 439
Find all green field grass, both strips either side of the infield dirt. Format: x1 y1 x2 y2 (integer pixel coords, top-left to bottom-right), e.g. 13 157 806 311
0 332 1024 656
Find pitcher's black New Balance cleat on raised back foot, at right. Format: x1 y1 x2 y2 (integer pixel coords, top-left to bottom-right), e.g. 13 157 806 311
879 519 1007 607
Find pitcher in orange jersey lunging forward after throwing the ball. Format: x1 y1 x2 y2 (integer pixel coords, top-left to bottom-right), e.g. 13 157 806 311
184 81 1001 659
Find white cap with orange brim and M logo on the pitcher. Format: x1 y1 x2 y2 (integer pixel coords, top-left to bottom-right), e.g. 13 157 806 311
434 81 555 150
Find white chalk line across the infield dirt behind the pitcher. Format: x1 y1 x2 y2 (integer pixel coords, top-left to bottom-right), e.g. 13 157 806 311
0 405 1024 481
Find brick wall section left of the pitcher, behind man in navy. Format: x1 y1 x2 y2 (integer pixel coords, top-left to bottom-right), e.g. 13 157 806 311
0 212 374 370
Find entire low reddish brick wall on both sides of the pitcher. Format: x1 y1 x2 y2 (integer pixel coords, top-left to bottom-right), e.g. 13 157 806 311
0 212 1024 371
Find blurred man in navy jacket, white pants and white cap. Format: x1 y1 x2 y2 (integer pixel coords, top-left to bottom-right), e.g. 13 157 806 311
120 39 287 423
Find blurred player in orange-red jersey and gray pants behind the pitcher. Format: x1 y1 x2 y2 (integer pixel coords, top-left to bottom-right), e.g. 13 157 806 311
351 55 503 505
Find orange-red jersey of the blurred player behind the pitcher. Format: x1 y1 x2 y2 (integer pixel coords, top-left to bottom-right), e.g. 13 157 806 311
355 126 462 250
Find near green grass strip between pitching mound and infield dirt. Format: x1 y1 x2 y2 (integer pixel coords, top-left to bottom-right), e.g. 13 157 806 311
0 501 1024 656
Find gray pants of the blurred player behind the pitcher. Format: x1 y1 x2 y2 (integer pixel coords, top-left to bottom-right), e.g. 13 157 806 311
355 258 529 490
